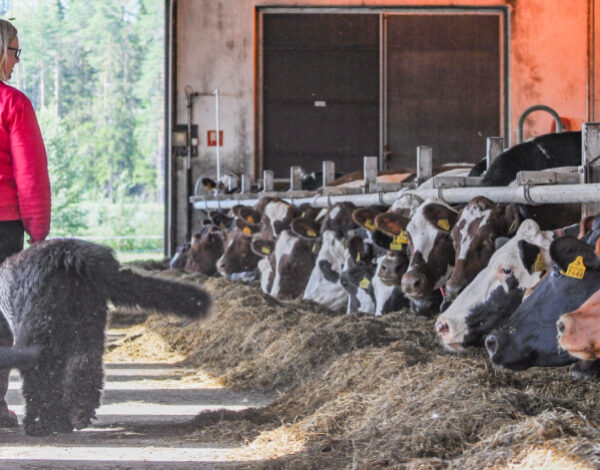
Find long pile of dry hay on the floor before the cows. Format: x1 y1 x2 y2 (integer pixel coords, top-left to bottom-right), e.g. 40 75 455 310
112 273 600 469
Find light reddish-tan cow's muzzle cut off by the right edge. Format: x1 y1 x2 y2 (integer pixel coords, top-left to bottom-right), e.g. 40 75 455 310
556 291 600 361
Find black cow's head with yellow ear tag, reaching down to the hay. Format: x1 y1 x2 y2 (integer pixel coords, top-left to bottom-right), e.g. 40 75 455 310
485 236 600 370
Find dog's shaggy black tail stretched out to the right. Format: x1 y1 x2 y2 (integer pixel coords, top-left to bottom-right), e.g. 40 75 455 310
106 269 211 318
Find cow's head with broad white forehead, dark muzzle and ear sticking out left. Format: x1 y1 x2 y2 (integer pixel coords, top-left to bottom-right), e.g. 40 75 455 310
375 200 458 315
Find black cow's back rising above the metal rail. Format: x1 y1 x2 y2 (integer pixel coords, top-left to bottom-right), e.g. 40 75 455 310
480 131 581 186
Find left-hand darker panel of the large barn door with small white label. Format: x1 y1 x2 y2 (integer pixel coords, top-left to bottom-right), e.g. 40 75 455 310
262 13 379 178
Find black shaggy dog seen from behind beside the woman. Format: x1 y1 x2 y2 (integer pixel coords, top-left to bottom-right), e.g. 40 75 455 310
0 239 210 436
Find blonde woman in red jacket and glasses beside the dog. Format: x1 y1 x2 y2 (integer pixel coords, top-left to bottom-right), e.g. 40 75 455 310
0 19 50 427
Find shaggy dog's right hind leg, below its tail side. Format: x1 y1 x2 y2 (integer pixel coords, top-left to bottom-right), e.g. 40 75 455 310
63 333 104 429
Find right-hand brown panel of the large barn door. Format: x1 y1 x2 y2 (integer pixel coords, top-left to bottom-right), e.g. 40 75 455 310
386 14 502 167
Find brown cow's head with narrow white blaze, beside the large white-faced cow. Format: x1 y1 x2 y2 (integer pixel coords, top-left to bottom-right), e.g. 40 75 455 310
444 197 521 302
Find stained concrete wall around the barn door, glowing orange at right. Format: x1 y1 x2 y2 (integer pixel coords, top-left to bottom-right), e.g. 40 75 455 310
174 0 600 248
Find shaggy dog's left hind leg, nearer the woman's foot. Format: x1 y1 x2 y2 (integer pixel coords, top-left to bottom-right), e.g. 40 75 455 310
21 360 73 436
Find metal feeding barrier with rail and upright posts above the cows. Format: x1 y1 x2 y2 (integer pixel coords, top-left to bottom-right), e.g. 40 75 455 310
190 123 600 215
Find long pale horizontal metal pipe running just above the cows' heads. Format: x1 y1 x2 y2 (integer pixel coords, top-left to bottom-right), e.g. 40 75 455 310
193 183 600 209
